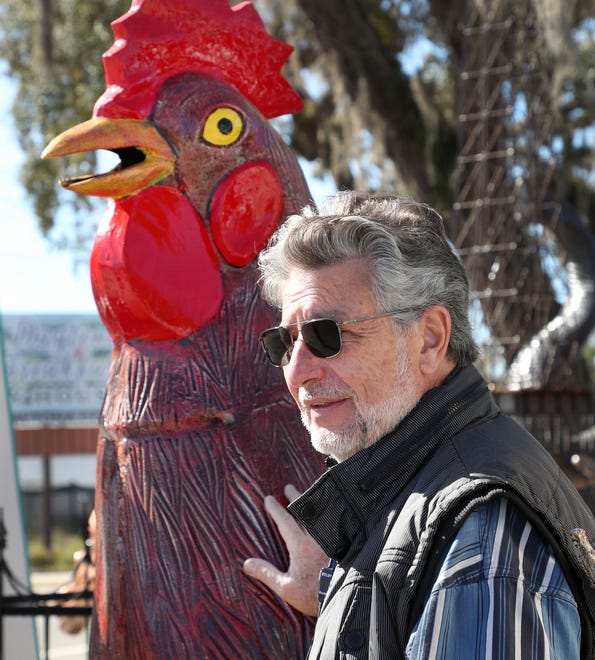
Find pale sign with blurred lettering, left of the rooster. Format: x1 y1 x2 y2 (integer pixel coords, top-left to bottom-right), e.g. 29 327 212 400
0 314 113 426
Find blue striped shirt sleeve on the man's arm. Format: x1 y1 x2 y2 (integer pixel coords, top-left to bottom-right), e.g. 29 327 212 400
406 499 580 660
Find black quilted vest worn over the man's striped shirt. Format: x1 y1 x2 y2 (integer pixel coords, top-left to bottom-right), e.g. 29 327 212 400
290 367 595 659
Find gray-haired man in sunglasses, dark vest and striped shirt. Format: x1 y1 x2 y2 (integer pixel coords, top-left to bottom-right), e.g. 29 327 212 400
245 192 595 660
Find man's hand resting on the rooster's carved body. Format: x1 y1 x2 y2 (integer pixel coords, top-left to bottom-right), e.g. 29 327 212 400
244 486 328 616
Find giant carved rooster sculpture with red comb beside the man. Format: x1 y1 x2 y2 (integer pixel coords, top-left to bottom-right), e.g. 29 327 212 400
43 0 322 659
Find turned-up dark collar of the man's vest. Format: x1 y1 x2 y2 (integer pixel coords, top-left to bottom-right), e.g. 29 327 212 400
289 366 497 561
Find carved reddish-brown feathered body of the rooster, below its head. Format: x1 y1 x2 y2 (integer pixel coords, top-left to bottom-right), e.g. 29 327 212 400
92 272 314 658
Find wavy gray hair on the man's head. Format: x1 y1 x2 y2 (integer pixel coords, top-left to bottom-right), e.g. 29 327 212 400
258 191 479 366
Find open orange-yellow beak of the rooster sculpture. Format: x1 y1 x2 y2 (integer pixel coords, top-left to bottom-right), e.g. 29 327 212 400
41 117 175 199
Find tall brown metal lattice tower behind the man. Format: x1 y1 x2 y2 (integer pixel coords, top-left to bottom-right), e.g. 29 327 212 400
455 0 564 381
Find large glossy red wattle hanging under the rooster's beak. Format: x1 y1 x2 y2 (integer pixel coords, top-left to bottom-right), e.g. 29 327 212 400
91 186 223 344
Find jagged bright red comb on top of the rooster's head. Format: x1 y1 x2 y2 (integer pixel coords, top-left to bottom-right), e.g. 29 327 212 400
93 0 302 119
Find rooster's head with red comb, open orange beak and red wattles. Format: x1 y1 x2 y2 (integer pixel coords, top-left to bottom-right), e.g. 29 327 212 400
42 0 309 343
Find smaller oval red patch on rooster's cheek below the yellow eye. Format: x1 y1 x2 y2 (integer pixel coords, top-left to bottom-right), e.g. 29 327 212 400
210 160 283 267
